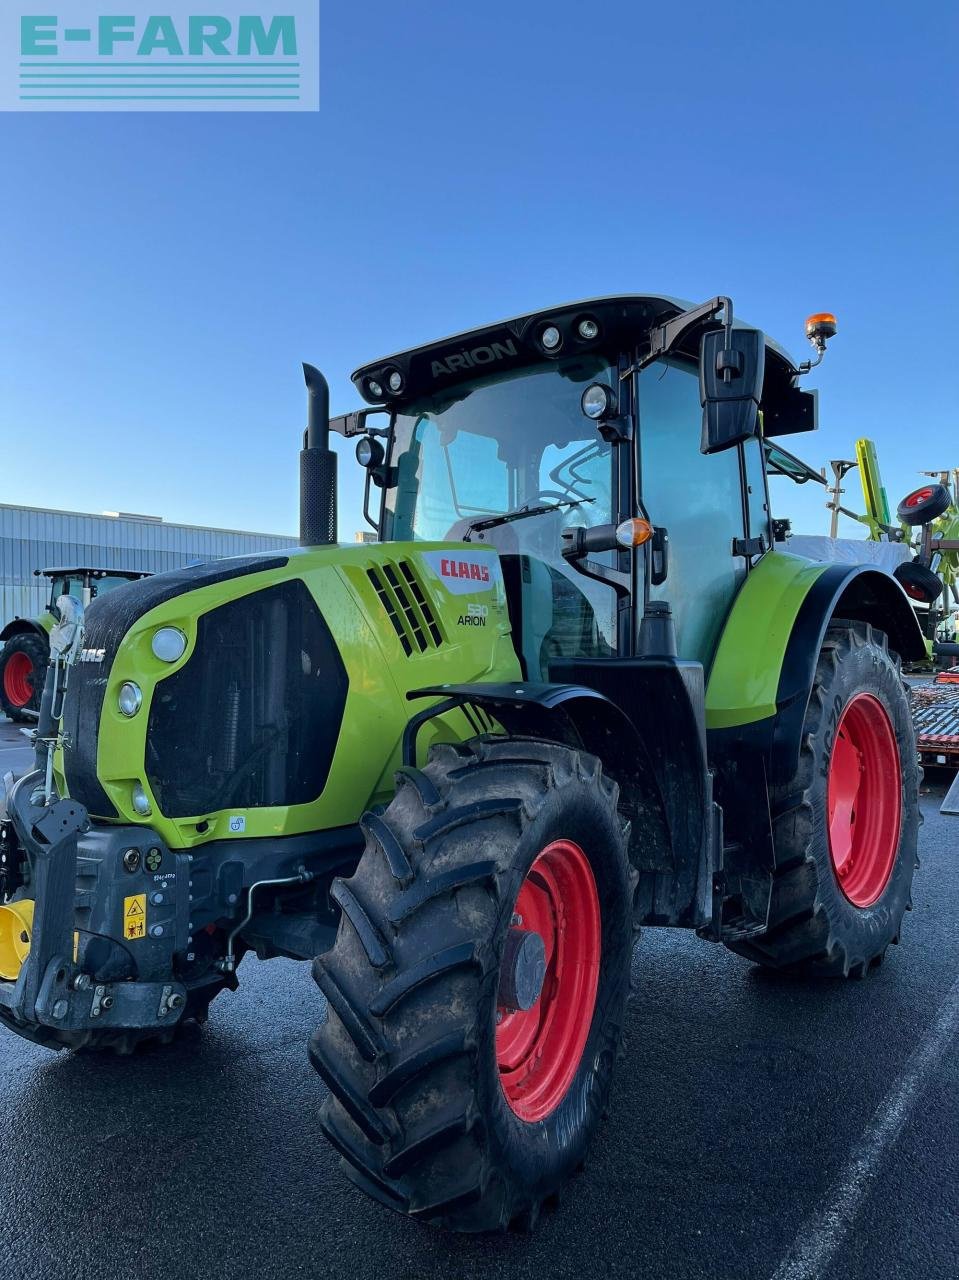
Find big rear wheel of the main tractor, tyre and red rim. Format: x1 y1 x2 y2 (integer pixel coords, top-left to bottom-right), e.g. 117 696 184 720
730 622 919 978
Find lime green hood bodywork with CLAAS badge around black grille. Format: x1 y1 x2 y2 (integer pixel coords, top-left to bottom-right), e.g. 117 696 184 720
60 543 520 847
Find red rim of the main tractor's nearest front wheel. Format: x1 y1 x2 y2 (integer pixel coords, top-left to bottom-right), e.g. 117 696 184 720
496 840 602 1123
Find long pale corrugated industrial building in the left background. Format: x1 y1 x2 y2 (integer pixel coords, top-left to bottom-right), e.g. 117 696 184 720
0 503 296 626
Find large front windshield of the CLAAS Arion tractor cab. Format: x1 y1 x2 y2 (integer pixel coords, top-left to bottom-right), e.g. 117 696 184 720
384 356 616 677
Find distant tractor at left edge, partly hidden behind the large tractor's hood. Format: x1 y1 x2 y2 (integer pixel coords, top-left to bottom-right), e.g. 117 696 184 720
0 568 150 721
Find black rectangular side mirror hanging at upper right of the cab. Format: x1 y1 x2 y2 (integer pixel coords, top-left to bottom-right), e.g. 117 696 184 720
699 329 766 453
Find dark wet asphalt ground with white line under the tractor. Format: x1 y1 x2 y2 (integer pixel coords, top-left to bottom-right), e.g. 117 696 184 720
0 722 959 1280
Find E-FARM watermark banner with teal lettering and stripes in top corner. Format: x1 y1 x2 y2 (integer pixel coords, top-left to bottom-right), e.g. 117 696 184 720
0 0 320 111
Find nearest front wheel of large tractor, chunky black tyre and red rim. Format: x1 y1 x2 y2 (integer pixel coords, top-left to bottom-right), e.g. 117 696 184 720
310 739 636 1231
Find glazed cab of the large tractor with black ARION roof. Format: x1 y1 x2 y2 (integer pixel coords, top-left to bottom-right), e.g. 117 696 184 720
332 297 816 680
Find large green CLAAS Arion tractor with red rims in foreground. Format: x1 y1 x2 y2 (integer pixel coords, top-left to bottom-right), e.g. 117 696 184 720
0 296 923 1231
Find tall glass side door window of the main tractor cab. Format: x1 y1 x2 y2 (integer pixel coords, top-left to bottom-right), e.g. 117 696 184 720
639 361 745 667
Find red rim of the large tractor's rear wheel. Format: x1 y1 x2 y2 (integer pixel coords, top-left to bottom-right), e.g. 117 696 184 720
826 694 903 906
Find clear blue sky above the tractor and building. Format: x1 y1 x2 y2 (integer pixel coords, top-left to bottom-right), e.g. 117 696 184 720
0 0 959 536
